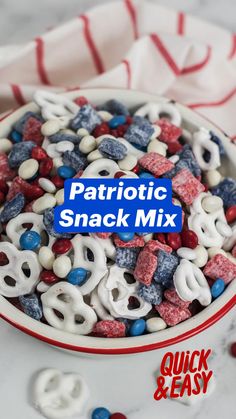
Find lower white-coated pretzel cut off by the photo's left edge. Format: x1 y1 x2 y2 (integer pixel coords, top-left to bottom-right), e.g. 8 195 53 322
0 242 41 298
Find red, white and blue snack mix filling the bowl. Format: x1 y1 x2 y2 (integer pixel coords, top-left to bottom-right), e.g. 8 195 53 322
0 91 236 338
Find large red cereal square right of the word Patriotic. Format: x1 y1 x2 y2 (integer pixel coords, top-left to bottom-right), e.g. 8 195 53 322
172 169 205 205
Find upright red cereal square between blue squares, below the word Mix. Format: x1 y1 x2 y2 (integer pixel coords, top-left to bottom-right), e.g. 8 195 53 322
134 250 157 286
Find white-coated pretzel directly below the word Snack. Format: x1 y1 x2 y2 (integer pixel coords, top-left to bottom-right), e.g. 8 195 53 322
71 234 107 295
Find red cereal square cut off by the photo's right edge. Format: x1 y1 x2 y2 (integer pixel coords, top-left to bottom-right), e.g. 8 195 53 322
203 254 236 284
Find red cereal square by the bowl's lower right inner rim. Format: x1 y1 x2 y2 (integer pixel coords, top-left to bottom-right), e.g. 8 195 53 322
155 301 192 326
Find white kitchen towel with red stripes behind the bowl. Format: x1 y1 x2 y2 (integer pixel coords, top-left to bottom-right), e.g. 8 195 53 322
0 0 236 139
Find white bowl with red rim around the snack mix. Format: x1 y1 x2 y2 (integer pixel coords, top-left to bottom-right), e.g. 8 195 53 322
0 89 236 355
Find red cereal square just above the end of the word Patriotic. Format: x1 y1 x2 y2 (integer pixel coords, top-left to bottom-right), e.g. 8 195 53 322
139 152 174 176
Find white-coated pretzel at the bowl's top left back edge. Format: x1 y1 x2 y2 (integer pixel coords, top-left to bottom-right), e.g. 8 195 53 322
34 90 80 120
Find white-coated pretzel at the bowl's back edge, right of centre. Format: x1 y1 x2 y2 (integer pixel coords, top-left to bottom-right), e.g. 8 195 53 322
135 102 182 126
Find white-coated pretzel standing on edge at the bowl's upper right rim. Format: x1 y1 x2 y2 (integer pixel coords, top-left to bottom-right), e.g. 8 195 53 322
191 128 220 170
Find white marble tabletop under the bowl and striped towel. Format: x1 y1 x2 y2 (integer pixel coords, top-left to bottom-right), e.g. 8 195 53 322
0 0 236 419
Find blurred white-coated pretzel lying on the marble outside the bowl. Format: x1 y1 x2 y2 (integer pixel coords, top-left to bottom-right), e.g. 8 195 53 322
33 368 89 419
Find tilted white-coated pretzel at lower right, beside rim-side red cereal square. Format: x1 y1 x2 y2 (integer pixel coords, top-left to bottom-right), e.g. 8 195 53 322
173 259 211 306
